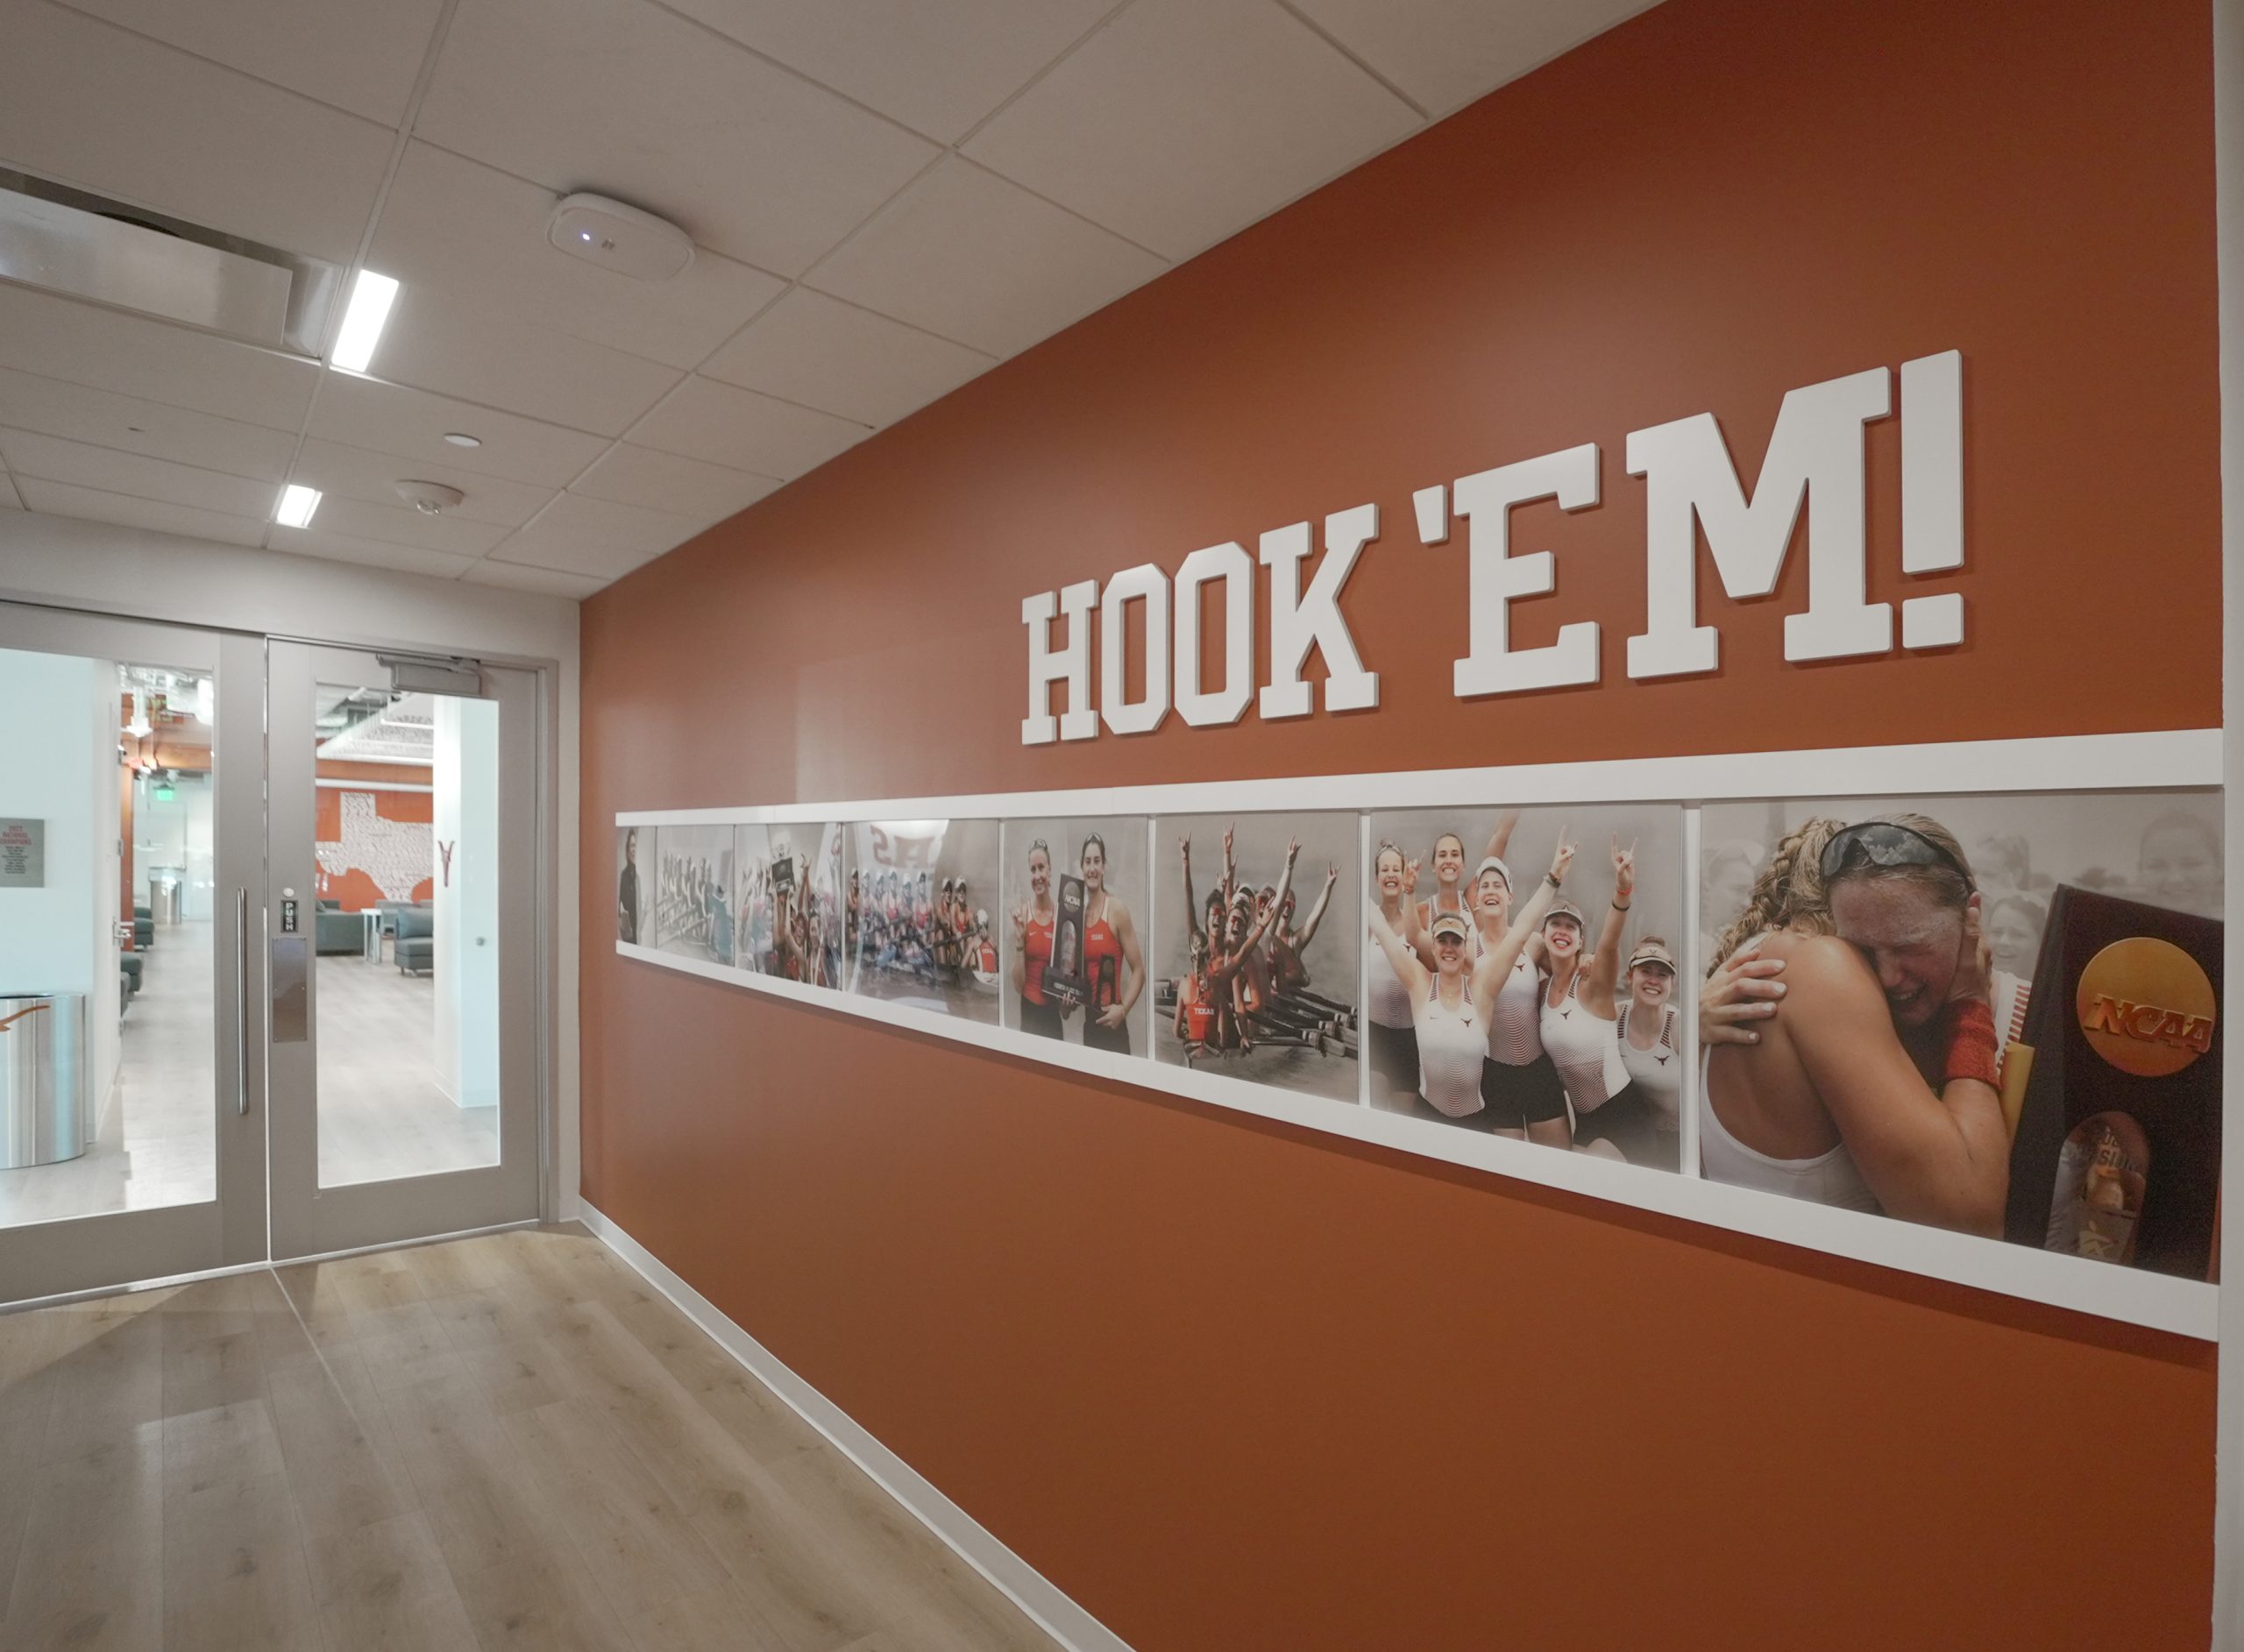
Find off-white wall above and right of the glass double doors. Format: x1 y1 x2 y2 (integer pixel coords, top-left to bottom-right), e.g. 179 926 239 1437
0 509 577 1216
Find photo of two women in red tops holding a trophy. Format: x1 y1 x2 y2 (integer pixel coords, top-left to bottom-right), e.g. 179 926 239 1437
1003 815 1151 1055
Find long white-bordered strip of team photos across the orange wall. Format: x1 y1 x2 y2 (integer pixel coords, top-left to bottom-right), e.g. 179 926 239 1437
614 736 2224 1336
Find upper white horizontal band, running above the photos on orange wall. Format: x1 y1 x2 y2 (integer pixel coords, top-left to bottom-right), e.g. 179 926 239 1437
614 729 2221 826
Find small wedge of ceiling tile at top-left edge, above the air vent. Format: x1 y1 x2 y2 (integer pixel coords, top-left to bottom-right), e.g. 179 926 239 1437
56 0 444 125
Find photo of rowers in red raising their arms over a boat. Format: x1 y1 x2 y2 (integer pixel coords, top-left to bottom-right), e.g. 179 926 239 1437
1154 812 1362 1103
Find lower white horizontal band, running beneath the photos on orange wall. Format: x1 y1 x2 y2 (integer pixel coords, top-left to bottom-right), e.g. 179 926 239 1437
614 940 2219 1343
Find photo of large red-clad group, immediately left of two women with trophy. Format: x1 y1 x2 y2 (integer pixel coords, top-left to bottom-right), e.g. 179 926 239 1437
842 819 1001 1021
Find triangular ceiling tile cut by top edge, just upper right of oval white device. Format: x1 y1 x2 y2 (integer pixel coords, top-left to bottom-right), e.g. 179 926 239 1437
673 0 1113 144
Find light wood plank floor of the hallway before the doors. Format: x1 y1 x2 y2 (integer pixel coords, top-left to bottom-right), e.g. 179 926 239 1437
0 1228 1057 1652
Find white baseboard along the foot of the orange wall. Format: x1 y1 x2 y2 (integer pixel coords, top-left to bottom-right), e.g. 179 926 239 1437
577 1201 1131 1652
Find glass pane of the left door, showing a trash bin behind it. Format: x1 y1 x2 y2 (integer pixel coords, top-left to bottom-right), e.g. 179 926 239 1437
0 649 217 1228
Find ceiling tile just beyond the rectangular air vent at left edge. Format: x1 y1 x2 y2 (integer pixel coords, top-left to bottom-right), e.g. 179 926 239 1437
0 287 319 433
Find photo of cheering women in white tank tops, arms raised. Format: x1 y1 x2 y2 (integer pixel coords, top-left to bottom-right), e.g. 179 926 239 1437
1364 805 1686 1169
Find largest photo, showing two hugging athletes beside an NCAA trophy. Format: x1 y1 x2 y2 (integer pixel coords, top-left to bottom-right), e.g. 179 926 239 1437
1696 792 2224 1277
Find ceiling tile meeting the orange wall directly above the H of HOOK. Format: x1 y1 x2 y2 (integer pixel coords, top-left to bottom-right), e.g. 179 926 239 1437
808 157 1167 357
